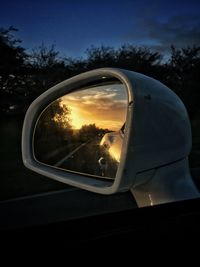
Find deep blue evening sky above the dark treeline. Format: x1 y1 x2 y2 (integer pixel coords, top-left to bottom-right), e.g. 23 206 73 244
0 0 200 58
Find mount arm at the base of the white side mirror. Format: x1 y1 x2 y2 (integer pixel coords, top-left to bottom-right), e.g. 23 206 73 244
131 158 200 207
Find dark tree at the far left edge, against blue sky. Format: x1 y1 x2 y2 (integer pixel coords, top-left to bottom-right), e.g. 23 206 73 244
0 27 27 116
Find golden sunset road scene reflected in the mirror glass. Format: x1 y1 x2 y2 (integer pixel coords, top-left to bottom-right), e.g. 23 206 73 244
33 82 128 179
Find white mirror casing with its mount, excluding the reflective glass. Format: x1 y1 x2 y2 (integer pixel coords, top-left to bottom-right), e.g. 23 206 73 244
22 68 199 207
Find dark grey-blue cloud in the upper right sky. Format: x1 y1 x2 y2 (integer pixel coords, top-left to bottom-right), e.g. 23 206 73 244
126 14 200 52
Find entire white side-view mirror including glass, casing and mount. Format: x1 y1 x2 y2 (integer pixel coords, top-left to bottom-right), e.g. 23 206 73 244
22 68 199 207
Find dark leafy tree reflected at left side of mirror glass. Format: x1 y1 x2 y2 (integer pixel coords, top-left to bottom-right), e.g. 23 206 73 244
34 99 73 163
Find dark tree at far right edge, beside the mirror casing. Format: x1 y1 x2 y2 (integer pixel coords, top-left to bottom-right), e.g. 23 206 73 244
166 46 200 119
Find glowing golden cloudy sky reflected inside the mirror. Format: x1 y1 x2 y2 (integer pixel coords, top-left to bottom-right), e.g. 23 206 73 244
61 84 128 131
